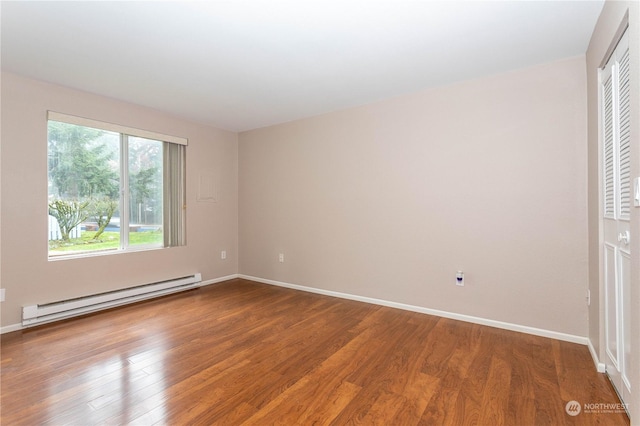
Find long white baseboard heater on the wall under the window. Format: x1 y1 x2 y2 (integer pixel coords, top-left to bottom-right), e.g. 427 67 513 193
22 273 202 327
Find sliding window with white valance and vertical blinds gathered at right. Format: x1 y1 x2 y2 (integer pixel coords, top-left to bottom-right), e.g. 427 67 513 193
48 111 187 259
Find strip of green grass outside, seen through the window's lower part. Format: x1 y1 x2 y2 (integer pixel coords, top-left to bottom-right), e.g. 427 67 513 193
49 231 164 256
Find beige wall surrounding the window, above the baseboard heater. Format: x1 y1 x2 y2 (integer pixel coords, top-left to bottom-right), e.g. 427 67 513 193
1 73 238 326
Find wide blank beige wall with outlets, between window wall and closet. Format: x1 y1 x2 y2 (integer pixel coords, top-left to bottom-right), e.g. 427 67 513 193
239 57 588 336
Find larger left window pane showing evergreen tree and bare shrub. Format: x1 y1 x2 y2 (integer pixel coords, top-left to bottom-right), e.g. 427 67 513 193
48 121 120 256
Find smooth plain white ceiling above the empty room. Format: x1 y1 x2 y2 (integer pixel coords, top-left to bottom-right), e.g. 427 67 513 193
1 0 604 131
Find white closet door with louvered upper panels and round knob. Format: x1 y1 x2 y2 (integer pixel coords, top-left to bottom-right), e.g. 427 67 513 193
600 30 631 410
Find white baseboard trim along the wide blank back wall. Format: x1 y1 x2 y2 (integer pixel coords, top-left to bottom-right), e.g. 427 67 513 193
238 274 590 345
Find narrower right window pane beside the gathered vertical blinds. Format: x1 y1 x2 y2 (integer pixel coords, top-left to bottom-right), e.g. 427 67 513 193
128 136 164 247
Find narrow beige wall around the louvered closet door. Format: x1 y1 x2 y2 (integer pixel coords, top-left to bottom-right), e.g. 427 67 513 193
586 1 640 424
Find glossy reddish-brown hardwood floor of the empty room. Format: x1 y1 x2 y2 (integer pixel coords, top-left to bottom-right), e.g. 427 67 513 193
0 279 629 425
